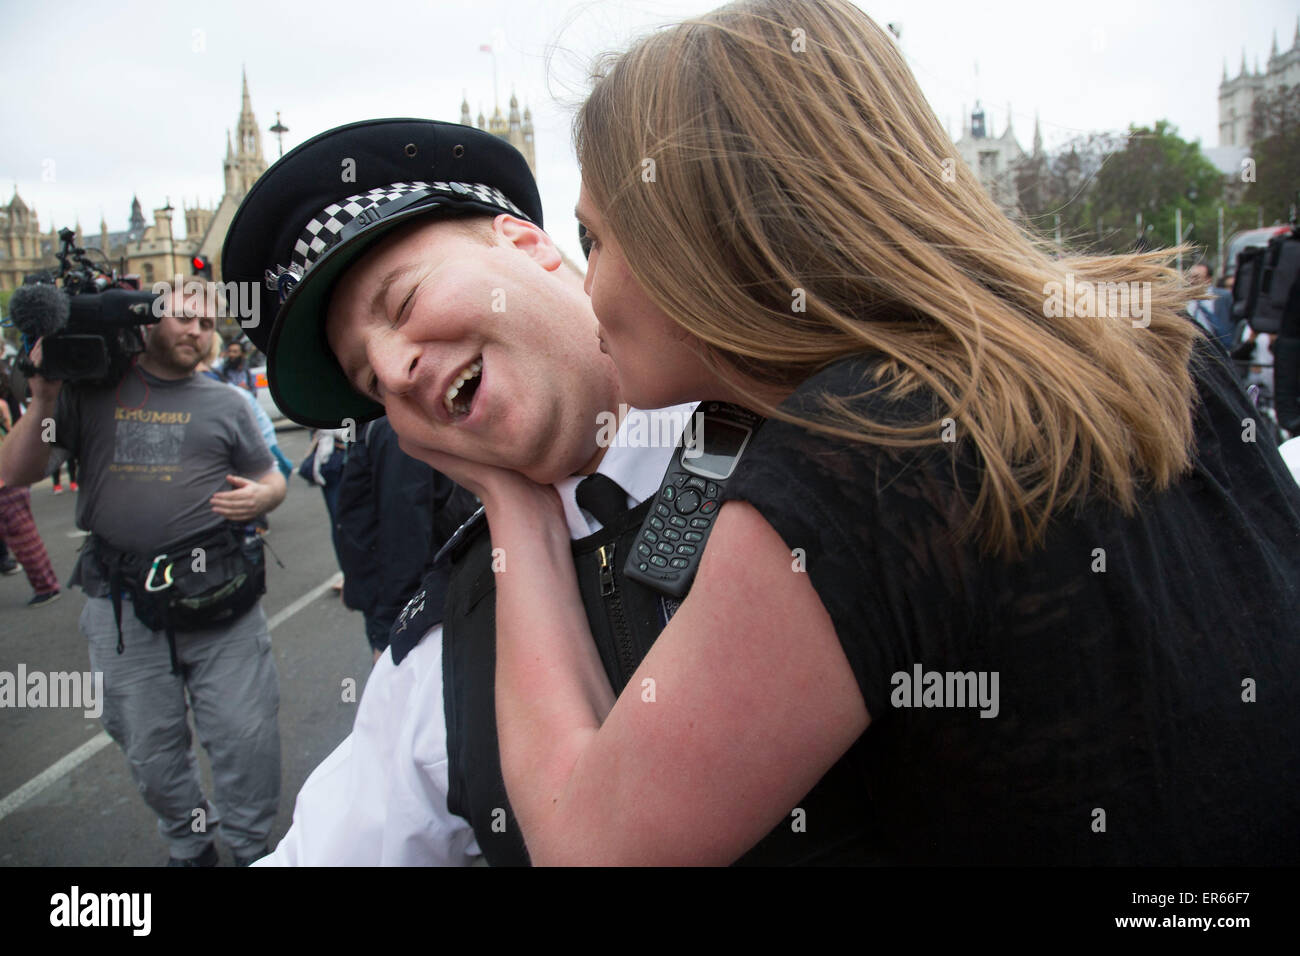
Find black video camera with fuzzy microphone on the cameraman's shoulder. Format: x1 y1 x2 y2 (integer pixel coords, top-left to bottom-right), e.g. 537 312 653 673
9 229 160 385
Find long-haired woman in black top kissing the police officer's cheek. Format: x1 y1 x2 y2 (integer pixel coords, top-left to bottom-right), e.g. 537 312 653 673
426 0 1300 864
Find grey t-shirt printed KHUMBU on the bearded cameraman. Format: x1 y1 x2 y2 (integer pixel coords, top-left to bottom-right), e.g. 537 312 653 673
55 367 274 597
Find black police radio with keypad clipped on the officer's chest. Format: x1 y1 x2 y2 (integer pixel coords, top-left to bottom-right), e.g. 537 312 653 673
623 402 764 597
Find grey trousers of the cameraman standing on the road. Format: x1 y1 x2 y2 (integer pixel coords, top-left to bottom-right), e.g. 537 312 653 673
81 597 280 860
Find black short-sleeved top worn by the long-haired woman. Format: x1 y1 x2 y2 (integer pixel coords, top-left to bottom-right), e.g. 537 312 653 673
725 343 1300 865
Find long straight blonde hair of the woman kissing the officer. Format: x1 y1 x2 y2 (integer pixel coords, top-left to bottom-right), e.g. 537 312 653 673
575 0 1197 555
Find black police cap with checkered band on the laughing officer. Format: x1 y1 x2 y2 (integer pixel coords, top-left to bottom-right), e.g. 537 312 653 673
221 120 542 428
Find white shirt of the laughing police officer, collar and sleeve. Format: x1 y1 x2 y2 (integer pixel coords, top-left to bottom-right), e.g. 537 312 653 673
256 405 694 866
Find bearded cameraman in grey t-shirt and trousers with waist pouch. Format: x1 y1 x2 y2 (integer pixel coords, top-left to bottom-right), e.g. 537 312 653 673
0 283 285 866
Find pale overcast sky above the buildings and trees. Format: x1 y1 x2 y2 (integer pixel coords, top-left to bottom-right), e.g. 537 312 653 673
0 0 1296 260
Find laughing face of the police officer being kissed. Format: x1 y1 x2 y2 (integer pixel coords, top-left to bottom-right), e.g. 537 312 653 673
325 216 619 483
